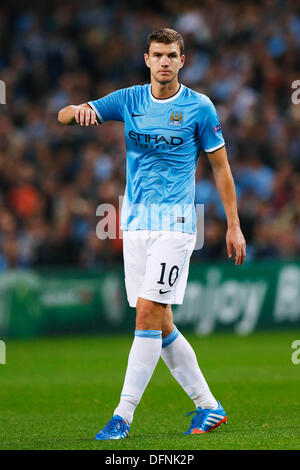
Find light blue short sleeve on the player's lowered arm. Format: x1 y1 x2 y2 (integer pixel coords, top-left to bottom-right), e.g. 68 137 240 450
198 96 225 153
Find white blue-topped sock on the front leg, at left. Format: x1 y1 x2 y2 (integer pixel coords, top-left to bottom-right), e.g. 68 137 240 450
114 330 162 425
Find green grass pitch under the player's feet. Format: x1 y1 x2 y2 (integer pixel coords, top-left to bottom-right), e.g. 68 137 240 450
0 330 300 450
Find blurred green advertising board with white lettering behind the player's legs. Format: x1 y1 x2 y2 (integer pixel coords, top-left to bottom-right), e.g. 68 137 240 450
0 262 300 339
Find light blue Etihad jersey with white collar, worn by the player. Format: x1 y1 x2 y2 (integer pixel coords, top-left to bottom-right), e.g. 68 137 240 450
88 84 225 233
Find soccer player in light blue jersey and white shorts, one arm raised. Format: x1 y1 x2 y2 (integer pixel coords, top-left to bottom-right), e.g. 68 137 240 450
58 28 246 440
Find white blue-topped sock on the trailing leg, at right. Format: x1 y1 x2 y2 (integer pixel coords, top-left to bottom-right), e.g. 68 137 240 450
161 326 218 409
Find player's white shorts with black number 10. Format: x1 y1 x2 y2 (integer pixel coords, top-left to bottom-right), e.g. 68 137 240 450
123 230 196 307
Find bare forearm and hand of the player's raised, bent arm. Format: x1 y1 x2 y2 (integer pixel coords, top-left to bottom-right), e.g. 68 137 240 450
57 103 99 126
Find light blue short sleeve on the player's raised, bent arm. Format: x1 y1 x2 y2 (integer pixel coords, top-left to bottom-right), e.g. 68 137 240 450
88 88 128 123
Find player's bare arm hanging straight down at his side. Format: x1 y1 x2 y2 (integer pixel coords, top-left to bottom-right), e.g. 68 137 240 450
207 146 246 265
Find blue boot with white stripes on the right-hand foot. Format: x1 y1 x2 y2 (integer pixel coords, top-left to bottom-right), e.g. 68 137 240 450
184 402 227 434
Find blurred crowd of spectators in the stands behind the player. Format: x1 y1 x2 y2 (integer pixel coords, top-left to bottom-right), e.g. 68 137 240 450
0 0 300 270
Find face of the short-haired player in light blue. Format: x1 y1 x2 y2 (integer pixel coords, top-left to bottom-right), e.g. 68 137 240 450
144 42 185 84
